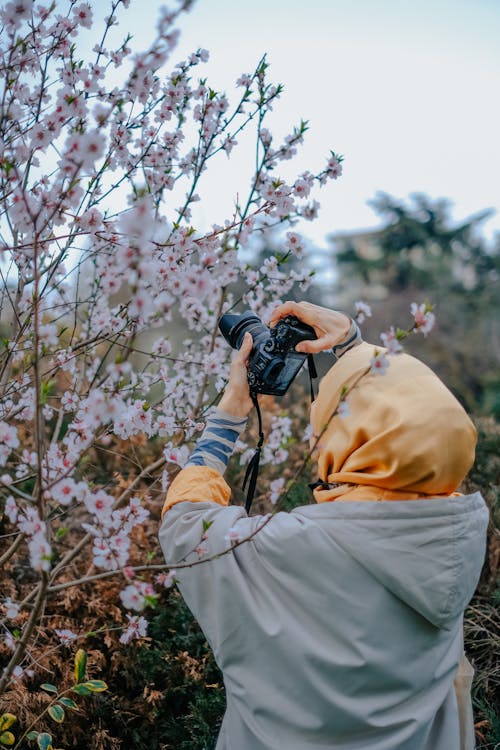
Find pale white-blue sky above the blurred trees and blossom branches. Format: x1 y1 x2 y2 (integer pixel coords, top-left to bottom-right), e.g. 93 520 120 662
106 0 500 245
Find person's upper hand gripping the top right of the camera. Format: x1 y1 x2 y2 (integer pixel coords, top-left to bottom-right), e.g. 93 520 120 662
269 302 351 354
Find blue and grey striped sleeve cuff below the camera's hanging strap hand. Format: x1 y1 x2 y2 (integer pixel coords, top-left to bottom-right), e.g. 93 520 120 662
186 409 247 474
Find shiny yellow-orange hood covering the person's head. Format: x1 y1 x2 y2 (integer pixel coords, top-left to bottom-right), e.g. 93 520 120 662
312 343 476 502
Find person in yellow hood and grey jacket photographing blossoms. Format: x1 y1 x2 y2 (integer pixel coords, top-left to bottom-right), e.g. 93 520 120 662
160 302 488 750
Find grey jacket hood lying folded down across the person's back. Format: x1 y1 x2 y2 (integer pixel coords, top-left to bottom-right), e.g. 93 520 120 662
297 493 488 628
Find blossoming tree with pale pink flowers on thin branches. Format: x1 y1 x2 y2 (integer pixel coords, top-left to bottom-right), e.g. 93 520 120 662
0 0 342 692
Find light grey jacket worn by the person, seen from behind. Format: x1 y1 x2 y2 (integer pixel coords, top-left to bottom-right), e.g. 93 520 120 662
160 493 488 750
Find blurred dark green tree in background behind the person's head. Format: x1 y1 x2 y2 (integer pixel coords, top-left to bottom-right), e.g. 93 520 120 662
330 193 500 417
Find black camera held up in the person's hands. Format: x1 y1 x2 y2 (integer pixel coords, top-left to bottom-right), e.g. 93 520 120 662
219 312 317 396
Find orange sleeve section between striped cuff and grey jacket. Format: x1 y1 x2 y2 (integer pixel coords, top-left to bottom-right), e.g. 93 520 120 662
161 466 231 518
